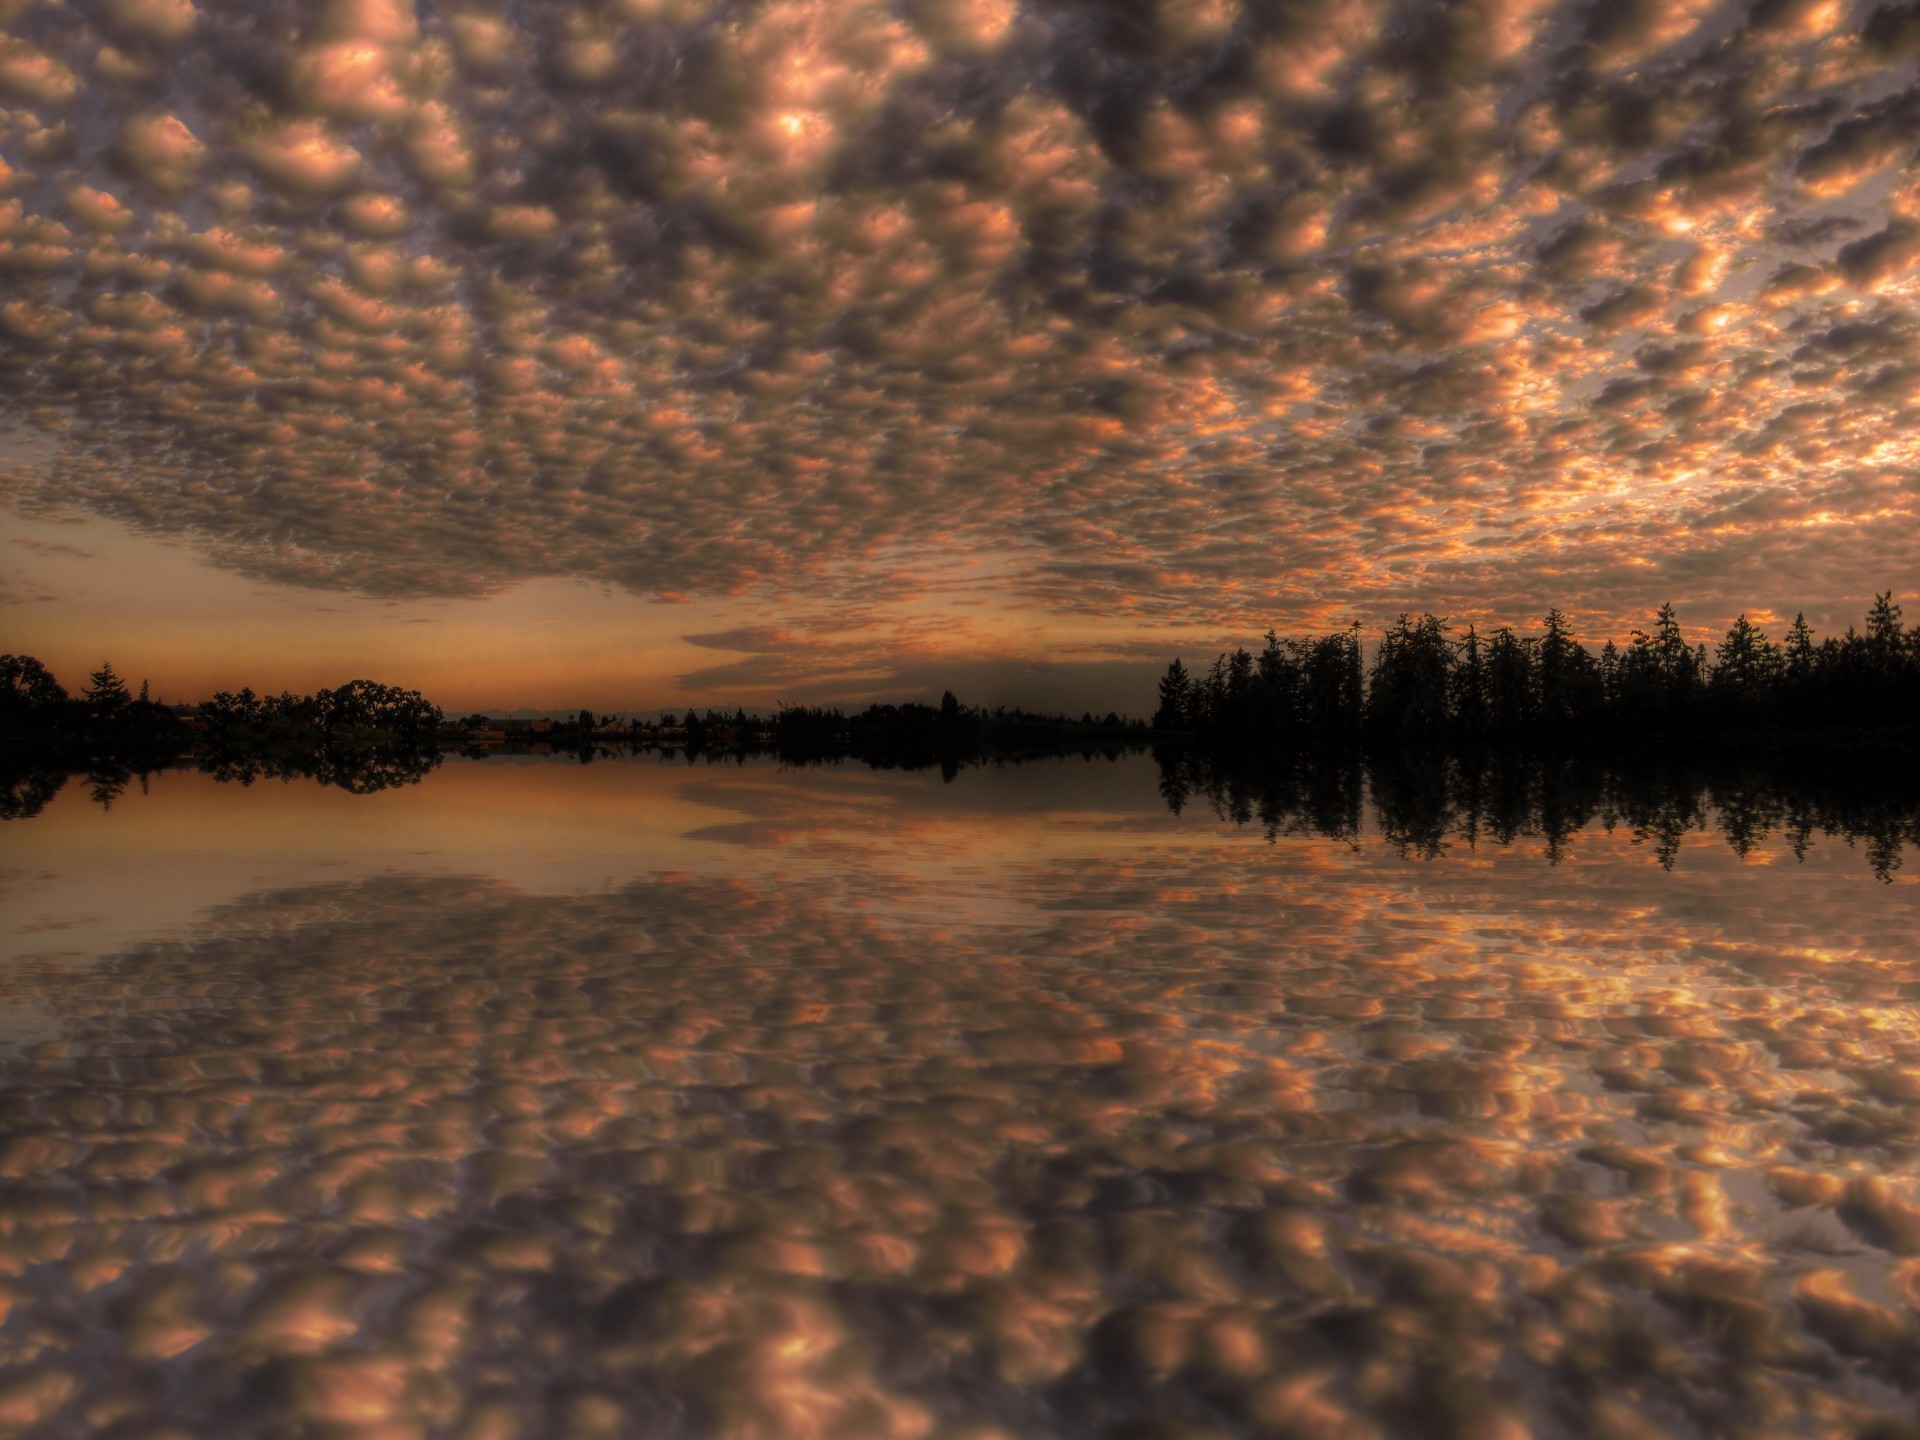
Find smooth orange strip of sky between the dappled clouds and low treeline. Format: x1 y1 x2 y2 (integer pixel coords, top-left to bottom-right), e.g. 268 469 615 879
0 511 1179 712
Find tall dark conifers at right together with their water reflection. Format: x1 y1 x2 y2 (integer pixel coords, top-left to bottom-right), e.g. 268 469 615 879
1154 591 1920 879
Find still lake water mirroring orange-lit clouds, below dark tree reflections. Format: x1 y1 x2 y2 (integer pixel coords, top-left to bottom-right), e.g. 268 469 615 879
0 758 1920 1440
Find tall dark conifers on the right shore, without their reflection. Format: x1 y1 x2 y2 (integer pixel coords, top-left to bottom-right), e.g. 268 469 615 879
1154 591 1920 753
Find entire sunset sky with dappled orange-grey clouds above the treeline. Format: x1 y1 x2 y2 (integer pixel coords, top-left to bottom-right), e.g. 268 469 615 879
0 0 1920 712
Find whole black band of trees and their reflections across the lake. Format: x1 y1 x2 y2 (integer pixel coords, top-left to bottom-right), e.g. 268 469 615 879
11 593 1920 877
